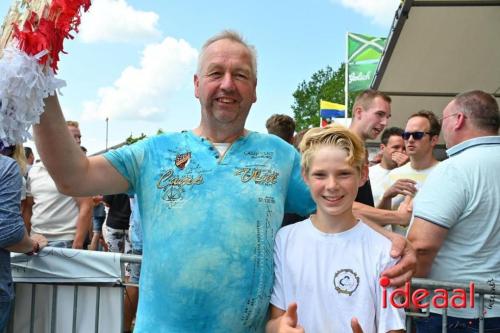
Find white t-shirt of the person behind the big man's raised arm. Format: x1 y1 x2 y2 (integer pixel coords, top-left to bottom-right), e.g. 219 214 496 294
26 163 79 241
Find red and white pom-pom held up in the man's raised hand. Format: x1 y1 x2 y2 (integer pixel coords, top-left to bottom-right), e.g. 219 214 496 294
0 0 90 144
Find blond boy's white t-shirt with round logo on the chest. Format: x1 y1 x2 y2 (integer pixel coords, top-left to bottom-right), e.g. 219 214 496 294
271 219 404 333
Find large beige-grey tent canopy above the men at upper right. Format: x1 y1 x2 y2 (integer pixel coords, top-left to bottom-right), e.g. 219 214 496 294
372 0 500 141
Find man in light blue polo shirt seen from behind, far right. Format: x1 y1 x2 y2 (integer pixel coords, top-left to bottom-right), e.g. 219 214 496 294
408 90 500 333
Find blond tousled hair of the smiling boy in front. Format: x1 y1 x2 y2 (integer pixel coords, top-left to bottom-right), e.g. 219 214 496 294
299 124 365 173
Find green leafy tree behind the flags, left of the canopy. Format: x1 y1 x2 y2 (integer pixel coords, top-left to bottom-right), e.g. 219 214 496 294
292 64 355 132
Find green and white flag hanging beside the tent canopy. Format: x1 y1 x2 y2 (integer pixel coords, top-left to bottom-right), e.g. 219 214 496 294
346 32 387 92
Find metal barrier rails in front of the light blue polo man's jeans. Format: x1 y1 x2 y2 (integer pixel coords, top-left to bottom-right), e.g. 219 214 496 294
406 278 500 333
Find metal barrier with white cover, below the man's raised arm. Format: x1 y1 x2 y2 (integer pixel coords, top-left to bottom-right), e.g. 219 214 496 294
7 249 141 333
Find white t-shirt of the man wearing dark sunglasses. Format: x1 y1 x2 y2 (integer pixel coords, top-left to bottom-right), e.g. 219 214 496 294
384 163 439 236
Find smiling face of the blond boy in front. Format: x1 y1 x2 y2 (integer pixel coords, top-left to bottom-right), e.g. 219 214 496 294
303 145 367 218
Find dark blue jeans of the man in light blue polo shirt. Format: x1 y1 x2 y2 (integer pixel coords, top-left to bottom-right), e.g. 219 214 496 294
415 313 500 333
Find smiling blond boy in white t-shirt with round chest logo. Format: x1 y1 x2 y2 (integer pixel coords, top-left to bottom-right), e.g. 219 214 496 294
266 125 404 333
